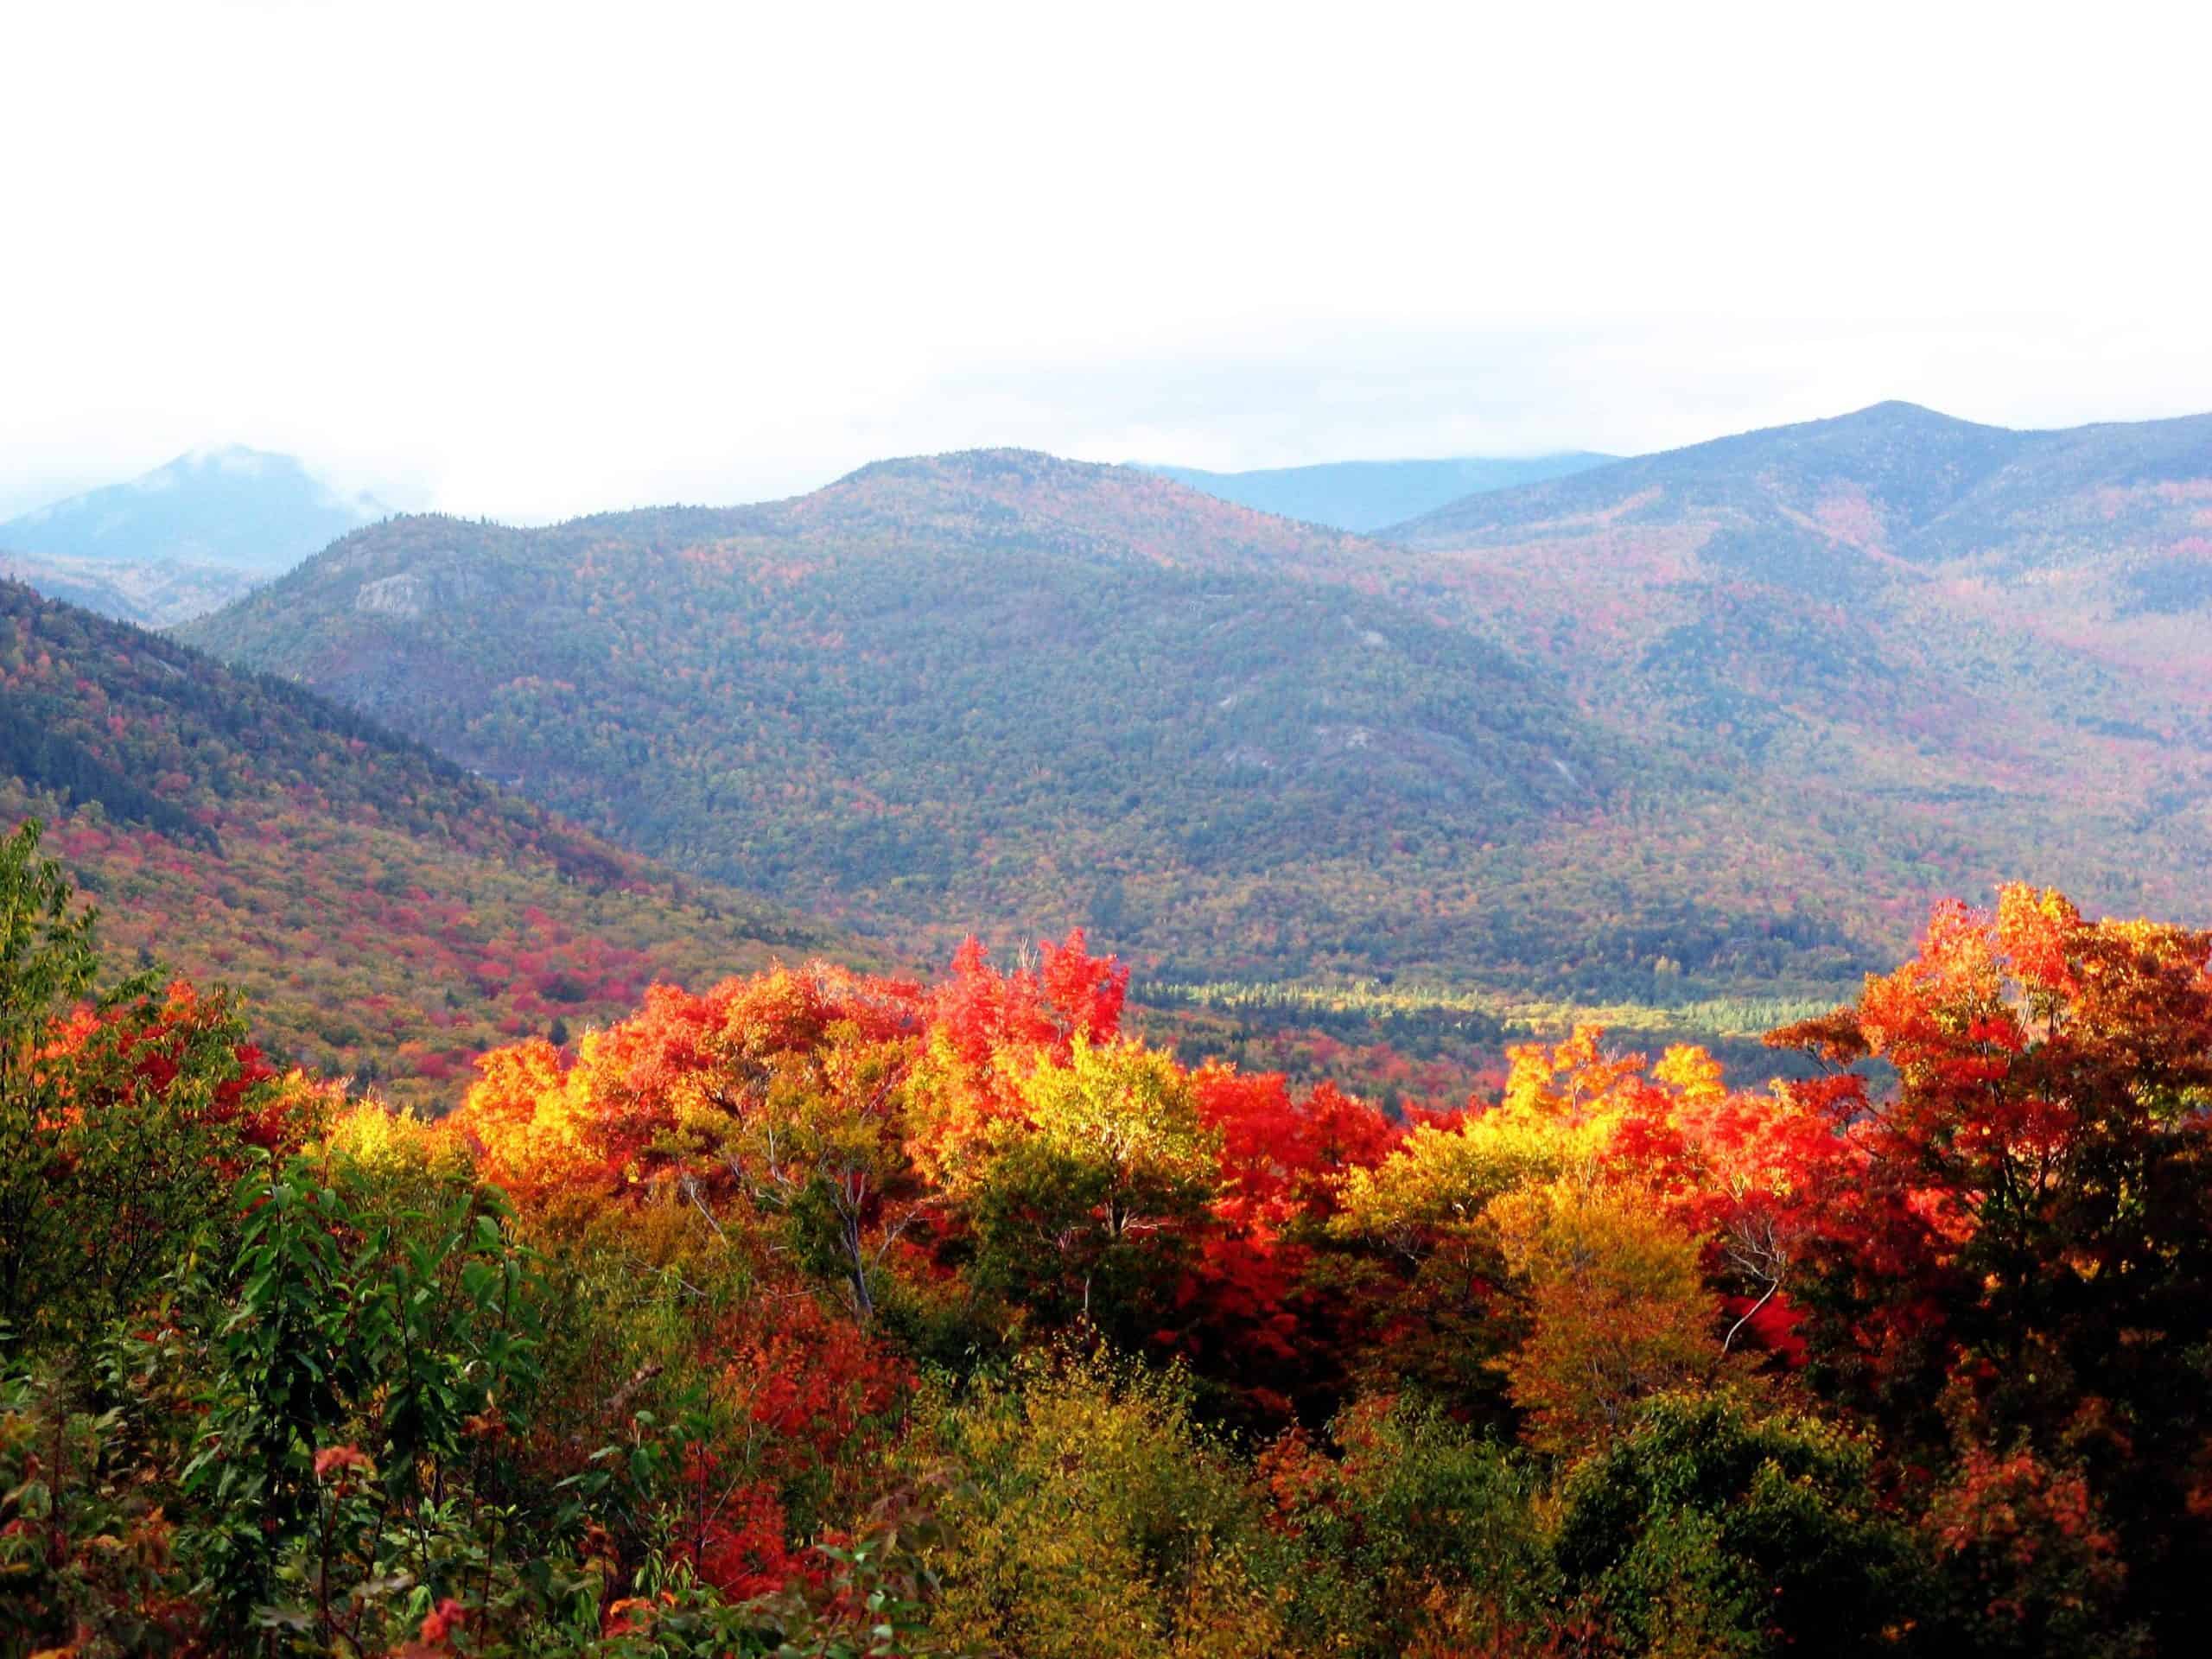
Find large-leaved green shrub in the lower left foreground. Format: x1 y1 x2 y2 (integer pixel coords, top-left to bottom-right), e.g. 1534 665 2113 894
181 1157 553 1646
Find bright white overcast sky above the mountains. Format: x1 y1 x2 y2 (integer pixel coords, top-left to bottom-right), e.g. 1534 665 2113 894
0 0 2212 522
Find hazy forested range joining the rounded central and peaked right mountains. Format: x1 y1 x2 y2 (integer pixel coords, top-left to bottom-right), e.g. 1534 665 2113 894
172 404 2212 1026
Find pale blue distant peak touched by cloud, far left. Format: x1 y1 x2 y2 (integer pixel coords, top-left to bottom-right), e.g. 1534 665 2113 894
0 445 387 577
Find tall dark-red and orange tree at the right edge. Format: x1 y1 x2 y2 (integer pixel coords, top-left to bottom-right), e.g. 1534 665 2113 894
1770 887 2212 1628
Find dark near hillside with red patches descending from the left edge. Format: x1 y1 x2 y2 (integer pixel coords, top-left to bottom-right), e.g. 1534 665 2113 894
0 582 868 1103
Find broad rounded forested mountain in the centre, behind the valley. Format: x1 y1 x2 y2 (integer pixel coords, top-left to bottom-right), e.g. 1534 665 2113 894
188 451 2052 1000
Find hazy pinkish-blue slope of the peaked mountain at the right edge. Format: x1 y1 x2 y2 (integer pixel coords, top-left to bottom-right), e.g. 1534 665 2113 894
1358 404 2212 938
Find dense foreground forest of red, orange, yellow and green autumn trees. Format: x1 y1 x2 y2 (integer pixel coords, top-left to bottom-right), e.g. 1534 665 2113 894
0 825 2212 1659
